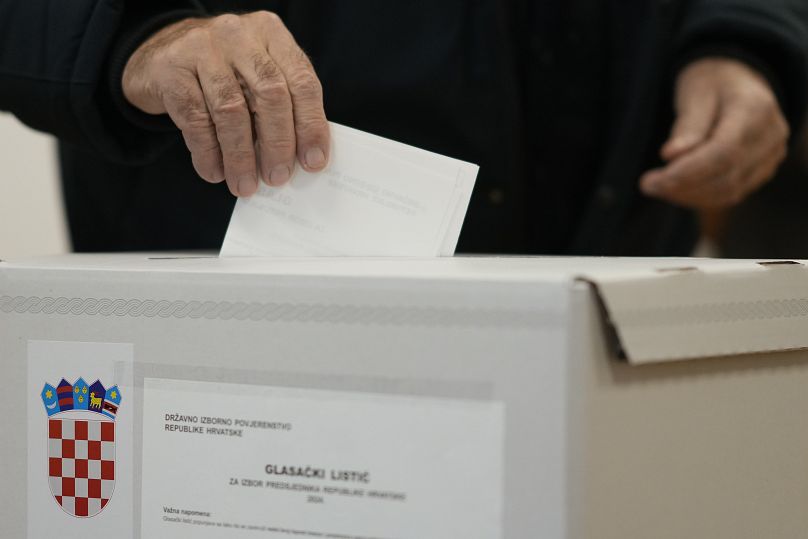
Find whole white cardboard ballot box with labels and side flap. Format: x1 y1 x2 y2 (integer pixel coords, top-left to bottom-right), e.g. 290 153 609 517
0 255 808 539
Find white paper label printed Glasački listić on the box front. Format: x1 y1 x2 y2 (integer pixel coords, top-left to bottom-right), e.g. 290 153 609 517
142 379 504 539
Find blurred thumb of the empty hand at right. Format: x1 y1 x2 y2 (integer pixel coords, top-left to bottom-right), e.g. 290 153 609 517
661 78 719 161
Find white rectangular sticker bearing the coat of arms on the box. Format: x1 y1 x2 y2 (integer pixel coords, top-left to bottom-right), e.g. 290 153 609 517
28 341 136 539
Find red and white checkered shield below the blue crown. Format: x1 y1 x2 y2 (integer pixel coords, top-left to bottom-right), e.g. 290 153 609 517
48 414 115 517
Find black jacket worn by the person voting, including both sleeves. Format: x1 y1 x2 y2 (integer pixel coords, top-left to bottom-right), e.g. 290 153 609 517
0 0 808 255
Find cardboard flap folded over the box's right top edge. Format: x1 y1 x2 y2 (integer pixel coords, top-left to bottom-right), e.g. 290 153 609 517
581 260 808 364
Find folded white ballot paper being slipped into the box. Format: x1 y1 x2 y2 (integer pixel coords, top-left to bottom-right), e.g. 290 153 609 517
221 124 479 257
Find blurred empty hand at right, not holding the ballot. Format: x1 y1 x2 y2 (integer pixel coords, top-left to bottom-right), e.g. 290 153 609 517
640 58 789 209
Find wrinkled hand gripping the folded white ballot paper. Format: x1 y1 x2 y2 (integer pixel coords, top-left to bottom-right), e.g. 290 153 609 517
123 11 330 196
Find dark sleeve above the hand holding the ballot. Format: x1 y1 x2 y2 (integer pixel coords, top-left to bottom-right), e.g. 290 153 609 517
0 0 198 163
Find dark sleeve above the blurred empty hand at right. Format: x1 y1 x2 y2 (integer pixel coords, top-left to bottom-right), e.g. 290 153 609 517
676 0 808 131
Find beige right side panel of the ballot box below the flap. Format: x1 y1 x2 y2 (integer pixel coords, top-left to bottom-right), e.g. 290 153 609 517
567 285 808 539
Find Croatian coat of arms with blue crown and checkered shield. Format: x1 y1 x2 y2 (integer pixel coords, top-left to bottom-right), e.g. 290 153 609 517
42 378 121 518
